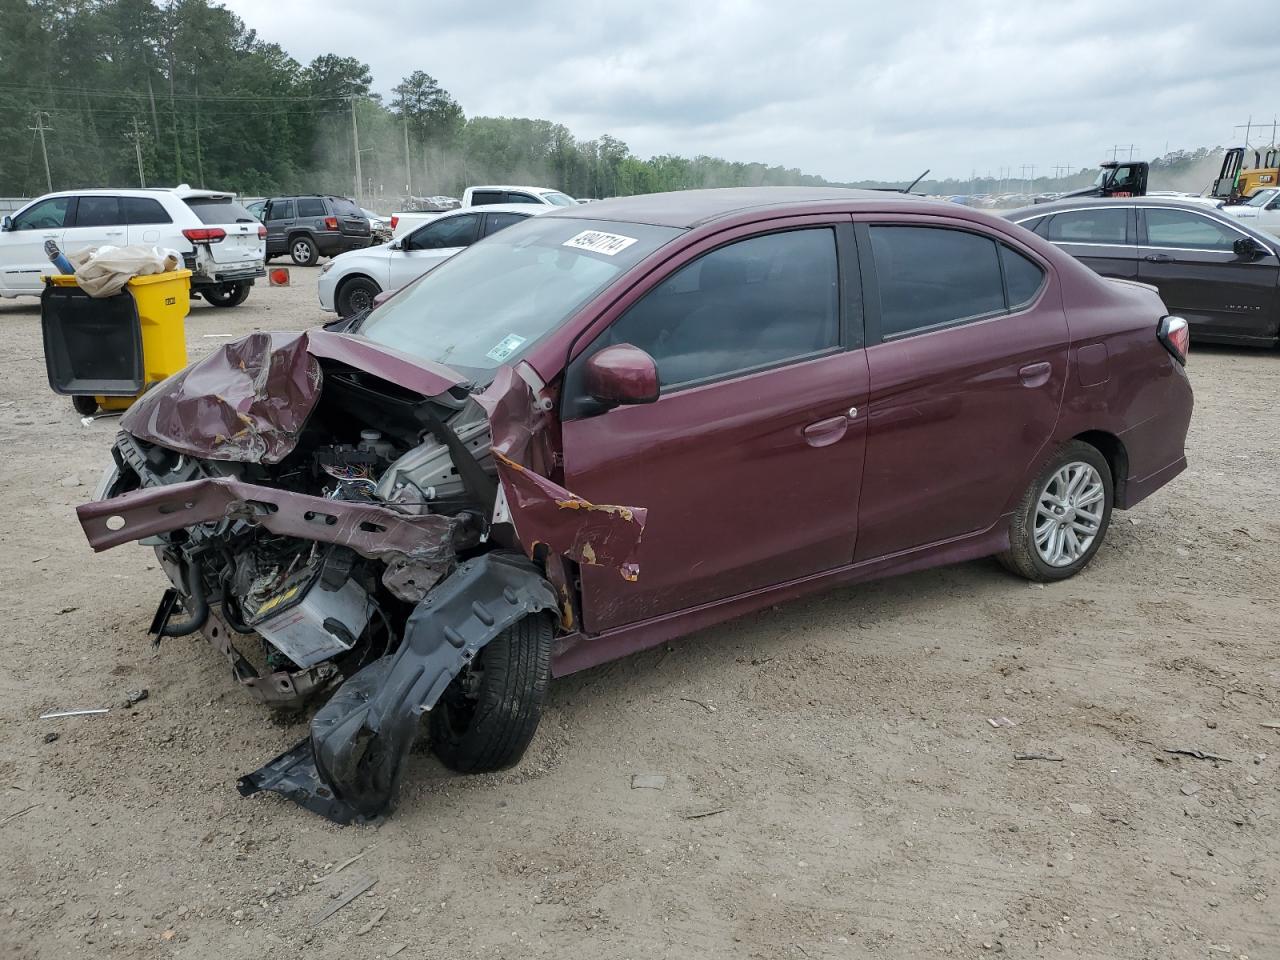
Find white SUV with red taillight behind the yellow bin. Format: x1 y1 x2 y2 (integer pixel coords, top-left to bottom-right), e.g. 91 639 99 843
0 184 266 307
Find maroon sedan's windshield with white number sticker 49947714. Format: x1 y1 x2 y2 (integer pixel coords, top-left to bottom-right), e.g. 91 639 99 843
360 216 681 383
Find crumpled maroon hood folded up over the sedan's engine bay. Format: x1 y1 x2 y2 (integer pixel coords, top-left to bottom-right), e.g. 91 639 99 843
120 330 465 463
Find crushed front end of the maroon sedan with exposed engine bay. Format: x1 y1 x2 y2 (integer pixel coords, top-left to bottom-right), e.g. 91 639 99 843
78 334 644 823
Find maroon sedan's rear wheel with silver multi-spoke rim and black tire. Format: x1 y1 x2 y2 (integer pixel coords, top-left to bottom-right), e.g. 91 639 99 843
998 440 1115 584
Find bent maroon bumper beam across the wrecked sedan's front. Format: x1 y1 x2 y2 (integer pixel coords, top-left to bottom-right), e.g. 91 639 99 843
76 476 465 567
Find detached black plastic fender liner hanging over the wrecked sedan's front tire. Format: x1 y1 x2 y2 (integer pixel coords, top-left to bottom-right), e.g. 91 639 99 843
238 553 559 823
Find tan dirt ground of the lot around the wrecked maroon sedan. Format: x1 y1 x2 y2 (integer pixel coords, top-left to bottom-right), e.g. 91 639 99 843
0 269 1280 960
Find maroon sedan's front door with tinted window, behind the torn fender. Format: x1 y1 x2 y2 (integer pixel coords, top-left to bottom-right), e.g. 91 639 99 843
562 221 867 634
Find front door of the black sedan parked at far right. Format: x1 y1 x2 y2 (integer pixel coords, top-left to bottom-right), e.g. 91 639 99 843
1138 207 1280 340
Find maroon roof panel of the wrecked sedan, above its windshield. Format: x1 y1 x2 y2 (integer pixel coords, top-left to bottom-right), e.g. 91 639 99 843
535 187 936 229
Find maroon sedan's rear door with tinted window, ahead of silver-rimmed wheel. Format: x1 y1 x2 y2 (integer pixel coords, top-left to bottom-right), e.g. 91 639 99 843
856 218 1070 561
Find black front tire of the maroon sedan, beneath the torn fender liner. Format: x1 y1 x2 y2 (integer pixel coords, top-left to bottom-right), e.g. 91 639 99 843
430 614 554 773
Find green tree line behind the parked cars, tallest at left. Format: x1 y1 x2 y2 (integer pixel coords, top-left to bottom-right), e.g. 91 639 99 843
0 0 824 205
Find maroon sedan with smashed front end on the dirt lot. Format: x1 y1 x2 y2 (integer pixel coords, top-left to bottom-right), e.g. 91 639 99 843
78 188 1192 822
